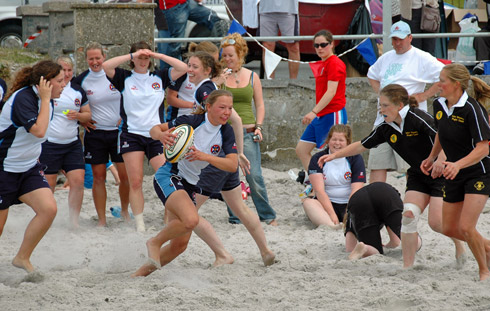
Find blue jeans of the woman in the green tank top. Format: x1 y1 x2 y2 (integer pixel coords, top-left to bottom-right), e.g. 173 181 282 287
228 131 276 223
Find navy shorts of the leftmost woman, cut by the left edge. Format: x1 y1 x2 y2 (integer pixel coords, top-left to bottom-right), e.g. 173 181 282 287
0 163 49 210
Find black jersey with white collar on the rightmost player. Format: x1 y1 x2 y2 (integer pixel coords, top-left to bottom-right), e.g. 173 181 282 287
434 92 490 175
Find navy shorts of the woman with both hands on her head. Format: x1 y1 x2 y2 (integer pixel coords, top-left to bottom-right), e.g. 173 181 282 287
119 132 163 160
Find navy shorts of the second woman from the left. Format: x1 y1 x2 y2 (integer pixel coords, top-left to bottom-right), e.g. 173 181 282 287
39 139 85 175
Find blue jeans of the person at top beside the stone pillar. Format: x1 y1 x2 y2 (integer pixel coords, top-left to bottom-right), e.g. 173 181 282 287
163 0 220 59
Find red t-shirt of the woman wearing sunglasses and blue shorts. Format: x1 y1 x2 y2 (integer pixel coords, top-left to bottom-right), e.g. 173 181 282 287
315 55 347 117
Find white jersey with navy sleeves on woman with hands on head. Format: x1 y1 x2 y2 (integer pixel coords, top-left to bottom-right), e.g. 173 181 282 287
110 68 175 138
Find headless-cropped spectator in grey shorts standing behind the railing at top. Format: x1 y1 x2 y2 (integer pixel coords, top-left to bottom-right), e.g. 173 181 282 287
259 0 300 79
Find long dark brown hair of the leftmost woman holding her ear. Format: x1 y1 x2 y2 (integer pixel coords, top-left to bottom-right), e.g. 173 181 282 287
8 60 63 97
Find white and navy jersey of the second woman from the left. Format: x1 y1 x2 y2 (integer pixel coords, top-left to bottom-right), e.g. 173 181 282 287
47 82 88 144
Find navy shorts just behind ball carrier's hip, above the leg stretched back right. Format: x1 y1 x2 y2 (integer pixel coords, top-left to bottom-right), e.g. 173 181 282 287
196 165 240 197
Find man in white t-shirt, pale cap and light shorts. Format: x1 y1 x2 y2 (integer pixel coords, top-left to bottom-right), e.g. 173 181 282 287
367 21 443 182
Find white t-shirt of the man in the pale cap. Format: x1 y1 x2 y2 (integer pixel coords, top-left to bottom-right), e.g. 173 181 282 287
367 46 444 125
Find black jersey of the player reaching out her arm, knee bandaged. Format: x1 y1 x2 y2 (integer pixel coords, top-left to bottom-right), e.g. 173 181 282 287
361 106 436 172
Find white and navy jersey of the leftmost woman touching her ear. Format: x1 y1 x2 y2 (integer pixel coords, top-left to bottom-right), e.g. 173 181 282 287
0 86 53 173
